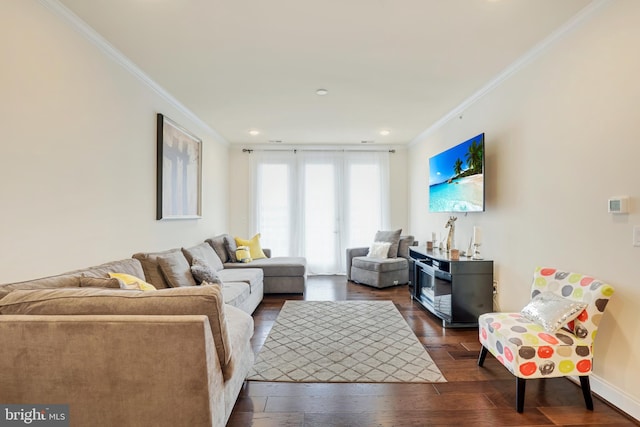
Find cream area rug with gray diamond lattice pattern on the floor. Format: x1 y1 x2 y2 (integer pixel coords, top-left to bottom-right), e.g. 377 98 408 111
247 301 446 383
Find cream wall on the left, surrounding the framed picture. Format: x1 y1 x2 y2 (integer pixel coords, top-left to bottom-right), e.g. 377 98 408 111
0 0 228 283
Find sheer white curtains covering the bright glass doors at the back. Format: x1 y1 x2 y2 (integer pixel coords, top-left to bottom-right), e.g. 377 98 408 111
251 150 390 274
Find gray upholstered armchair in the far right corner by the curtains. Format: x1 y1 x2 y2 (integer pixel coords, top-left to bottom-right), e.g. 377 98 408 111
347 236 418 288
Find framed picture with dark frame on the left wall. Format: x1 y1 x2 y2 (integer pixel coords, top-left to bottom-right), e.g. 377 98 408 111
156 114 202 220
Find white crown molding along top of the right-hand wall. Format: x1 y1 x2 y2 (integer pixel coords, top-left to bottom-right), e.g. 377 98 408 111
408 0 611 146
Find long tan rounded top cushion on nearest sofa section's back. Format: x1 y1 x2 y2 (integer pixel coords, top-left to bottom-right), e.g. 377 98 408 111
0 285 233 378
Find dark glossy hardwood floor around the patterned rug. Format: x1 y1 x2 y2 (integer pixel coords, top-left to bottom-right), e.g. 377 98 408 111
227 276 640 427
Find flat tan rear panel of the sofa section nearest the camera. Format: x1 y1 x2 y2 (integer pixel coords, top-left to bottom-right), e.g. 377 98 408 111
0 315 225 426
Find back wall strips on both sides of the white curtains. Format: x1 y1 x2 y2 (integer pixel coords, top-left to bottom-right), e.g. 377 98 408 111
229 146 411 242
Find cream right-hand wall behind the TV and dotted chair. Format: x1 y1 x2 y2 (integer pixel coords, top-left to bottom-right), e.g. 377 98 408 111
409 0 640 418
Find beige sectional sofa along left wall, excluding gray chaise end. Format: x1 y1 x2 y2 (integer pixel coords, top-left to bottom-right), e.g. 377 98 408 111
0 237 304 426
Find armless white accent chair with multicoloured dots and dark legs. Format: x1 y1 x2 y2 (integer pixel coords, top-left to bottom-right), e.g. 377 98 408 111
478 268 613 412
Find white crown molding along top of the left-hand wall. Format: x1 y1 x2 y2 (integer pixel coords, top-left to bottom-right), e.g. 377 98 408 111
38 0 229 146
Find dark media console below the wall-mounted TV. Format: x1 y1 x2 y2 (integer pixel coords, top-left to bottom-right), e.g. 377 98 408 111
409 247 493 328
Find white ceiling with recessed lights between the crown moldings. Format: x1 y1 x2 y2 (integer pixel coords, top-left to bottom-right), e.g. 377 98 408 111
60 0 591 144
